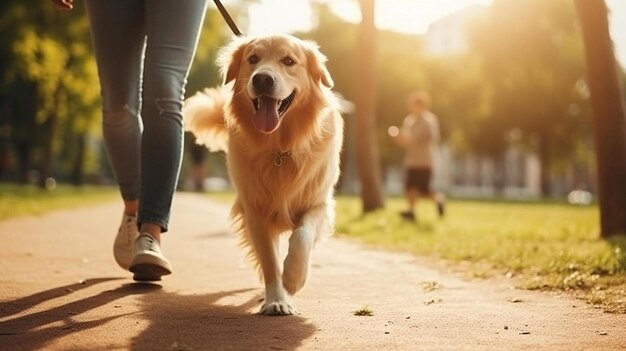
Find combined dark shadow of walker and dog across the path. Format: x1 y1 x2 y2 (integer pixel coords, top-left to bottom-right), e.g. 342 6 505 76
0 278 317 351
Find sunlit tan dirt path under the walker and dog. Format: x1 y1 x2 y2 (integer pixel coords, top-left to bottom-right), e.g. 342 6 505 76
0 194 626 350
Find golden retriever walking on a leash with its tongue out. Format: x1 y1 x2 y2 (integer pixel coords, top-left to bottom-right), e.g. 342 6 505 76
183 35 343 315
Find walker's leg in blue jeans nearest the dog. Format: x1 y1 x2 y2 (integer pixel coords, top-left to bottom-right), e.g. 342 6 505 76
139 0 206 241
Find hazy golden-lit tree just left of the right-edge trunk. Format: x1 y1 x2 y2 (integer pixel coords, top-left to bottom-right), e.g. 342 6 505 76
469 0 587 195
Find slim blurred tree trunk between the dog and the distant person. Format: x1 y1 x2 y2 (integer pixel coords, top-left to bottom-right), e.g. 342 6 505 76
355 0 384 212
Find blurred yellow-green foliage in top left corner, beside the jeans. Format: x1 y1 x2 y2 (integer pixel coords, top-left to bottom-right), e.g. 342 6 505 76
0 1 99 130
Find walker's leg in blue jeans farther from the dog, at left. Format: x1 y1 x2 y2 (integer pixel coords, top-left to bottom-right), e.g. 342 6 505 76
85 0 145 215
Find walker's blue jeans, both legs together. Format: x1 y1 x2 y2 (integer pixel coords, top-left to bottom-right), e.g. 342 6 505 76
85 0 206 232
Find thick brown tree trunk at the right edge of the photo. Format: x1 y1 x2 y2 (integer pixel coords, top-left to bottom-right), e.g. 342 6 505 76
574 0 626 238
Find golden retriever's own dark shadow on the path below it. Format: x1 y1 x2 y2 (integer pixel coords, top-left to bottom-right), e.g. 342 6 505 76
132 289 317 350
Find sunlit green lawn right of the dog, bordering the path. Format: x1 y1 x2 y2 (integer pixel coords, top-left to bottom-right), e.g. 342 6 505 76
337 196 626 313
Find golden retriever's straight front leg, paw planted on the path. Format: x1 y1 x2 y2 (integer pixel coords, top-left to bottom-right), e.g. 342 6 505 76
249 217 296 315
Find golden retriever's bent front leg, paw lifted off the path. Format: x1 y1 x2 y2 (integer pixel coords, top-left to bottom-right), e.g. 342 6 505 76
283 206 330 295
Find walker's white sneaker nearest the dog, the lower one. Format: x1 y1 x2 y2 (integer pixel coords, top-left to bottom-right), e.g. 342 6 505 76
129 233 172 281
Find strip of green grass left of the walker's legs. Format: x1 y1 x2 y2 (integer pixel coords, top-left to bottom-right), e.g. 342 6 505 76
0 184 119 220
